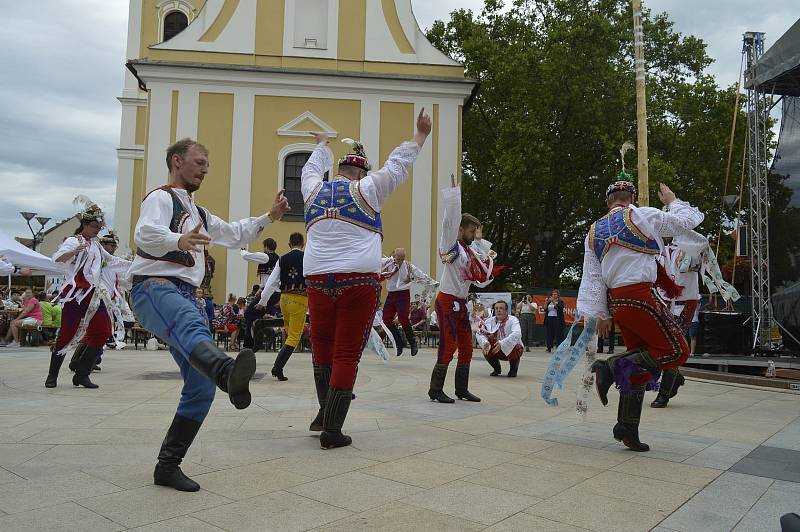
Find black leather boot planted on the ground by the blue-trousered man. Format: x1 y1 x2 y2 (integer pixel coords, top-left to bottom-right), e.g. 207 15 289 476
153 414 202 491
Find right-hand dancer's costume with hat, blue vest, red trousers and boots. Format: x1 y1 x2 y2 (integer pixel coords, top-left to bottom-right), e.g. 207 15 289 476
577 177 703 452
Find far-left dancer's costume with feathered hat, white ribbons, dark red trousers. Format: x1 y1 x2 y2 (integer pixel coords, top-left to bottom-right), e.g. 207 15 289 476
44 196 131 388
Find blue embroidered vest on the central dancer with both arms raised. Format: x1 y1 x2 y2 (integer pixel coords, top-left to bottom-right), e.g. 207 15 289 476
305 176 383 238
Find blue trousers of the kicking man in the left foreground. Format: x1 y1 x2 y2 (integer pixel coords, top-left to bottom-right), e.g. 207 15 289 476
131 277 217 423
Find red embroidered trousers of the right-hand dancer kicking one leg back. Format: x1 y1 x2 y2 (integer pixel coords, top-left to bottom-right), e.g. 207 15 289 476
609 283 689 384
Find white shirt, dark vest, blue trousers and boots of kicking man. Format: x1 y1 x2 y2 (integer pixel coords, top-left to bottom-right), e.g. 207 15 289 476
130 185 271 491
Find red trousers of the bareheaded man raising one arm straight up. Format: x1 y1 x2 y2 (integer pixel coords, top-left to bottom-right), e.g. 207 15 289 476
436 292 472 364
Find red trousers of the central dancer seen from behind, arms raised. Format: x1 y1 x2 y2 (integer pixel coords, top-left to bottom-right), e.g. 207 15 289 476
306 273 381 390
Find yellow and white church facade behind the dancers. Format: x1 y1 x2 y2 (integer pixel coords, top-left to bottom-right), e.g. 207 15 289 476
114 0 475 301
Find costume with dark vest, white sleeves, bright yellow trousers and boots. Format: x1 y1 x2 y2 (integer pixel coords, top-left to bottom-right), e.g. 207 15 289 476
258 248 308 381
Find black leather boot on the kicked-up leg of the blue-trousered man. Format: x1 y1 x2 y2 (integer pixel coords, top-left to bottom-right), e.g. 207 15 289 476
189 342 256 410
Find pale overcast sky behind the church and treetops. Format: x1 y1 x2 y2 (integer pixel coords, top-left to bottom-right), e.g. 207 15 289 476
0 0 800 242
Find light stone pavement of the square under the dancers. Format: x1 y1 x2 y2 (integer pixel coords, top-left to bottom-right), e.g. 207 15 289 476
0 342 800 532
